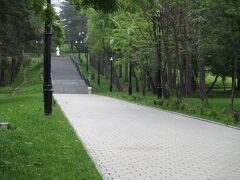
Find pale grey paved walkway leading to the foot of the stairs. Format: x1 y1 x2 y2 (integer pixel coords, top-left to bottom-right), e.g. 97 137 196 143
54 94 240 180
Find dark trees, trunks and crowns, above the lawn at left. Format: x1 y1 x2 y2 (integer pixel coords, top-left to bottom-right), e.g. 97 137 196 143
0 0 64 86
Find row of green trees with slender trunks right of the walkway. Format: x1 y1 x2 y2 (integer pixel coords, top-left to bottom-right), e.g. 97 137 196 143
68 0 240 106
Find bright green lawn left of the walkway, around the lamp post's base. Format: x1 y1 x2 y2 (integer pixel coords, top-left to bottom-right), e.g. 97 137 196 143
0 59 101 180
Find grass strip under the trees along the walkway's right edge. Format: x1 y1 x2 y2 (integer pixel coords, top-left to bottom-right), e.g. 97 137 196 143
75 53 240 127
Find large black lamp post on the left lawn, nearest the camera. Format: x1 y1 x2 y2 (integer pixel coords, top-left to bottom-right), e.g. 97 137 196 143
43 0 52 115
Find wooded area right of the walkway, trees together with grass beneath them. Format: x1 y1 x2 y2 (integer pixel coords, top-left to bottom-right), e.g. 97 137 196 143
62 0 240 124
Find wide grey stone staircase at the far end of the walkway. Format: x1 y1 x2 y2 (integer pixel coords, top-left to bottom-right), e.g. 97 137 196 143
52 57 88 94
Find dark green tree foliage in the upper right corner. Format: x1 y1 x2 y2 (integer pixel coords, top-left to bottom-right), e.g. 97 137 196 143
192 0 240 77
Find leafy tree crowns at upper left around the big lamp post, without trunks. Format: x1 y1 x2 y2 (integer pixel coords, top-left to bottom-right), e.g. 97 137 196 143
0 0 64 56
